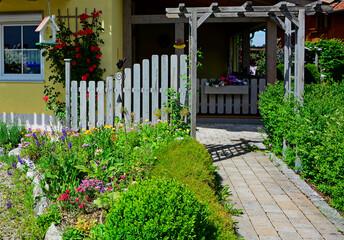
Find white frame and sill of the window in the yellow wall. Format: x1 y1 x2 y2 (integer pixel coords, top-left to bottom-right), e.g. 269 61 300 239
0 13 45 83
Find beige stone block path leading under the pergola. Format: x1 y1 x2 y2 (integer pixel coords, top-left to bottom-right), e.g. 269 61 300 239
197 124 344 240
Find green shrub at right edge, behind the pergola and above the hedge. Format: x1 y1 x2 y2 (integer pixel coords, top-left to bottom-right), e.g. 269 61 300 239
305 38 344 81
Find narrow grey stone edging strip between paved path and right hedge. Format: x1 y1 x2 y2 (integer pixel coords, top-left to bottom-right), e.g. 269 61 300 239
265 152 344 233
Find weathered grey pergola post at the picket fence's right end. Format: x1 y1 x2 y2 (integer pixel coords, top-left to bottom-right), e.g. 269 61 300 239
189 10 197 138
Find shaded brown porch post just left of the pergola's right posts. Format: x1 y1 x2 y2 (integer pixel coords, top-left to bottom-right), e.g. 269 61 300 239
266 19 277 84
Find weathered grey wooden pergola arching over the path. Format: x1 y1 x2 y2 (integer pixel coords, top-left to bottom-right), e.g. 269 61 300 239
166 1 330 137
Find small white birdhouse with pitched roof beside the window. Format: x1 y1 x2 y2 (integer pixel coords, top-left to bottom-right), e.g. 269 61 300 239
35 15 60 45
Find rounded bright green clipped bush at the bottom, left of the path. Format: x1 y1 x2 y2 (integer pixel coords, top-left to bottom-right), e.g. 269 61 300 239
93 179 213 240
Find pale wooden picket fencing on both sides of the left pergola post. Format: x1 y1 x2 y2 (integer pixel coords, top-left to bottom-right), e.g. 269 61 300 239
66 55 266 129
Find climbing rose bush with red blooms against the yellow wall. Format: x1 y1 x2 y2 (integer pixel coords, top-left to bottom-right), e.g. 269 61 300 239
43 11 105 119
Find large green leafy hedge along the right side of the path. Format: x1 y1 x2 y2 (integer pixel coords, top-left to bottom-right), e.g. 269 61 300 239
259 82 344 211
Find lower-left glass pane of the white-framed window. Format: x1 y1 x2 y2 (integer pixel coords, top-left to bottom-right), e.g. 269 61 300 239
4 50 23 74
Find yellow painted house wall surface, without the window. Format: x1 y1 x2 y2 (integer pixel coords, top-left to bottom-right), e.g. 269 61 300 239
0 0 123 114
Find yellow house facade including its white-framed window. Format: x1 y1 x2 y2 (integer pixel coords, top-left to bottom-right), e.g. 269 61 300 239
0 0 123 125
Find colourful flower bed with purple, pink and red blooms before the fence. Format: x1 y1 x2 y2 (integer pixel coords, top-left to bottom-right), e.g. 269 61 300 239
0 121 236 239
